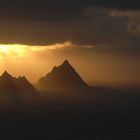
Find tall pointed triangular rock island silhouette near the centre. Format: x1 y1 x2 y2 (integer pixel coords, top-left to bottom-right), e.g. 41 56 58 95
37 60 87 87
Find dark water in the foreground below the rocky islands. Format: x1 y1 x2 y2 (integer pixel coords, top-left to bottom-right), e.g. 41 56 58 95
0 90 140 140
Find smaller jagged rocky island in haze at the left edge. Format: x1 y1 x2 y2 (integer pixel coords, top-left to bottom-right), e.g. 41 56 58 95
0 71 38 108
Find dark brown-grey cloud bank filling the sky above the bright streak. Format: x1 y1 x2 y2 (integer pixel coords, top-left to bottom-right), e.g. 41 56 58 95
0 0 140 56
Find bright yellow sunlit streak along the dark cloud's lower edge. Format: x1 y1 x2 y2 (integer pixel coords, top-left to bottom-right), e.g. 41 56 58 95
0 41 73 59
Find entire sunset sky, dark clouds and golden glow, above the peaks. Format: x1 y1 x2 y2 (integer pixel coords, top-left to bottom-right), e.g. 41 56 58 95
0 0 140 86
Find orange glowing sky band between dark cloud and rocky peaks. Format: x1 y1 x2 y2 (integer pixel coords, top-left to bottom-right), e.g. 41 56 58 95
0 41 140 85
